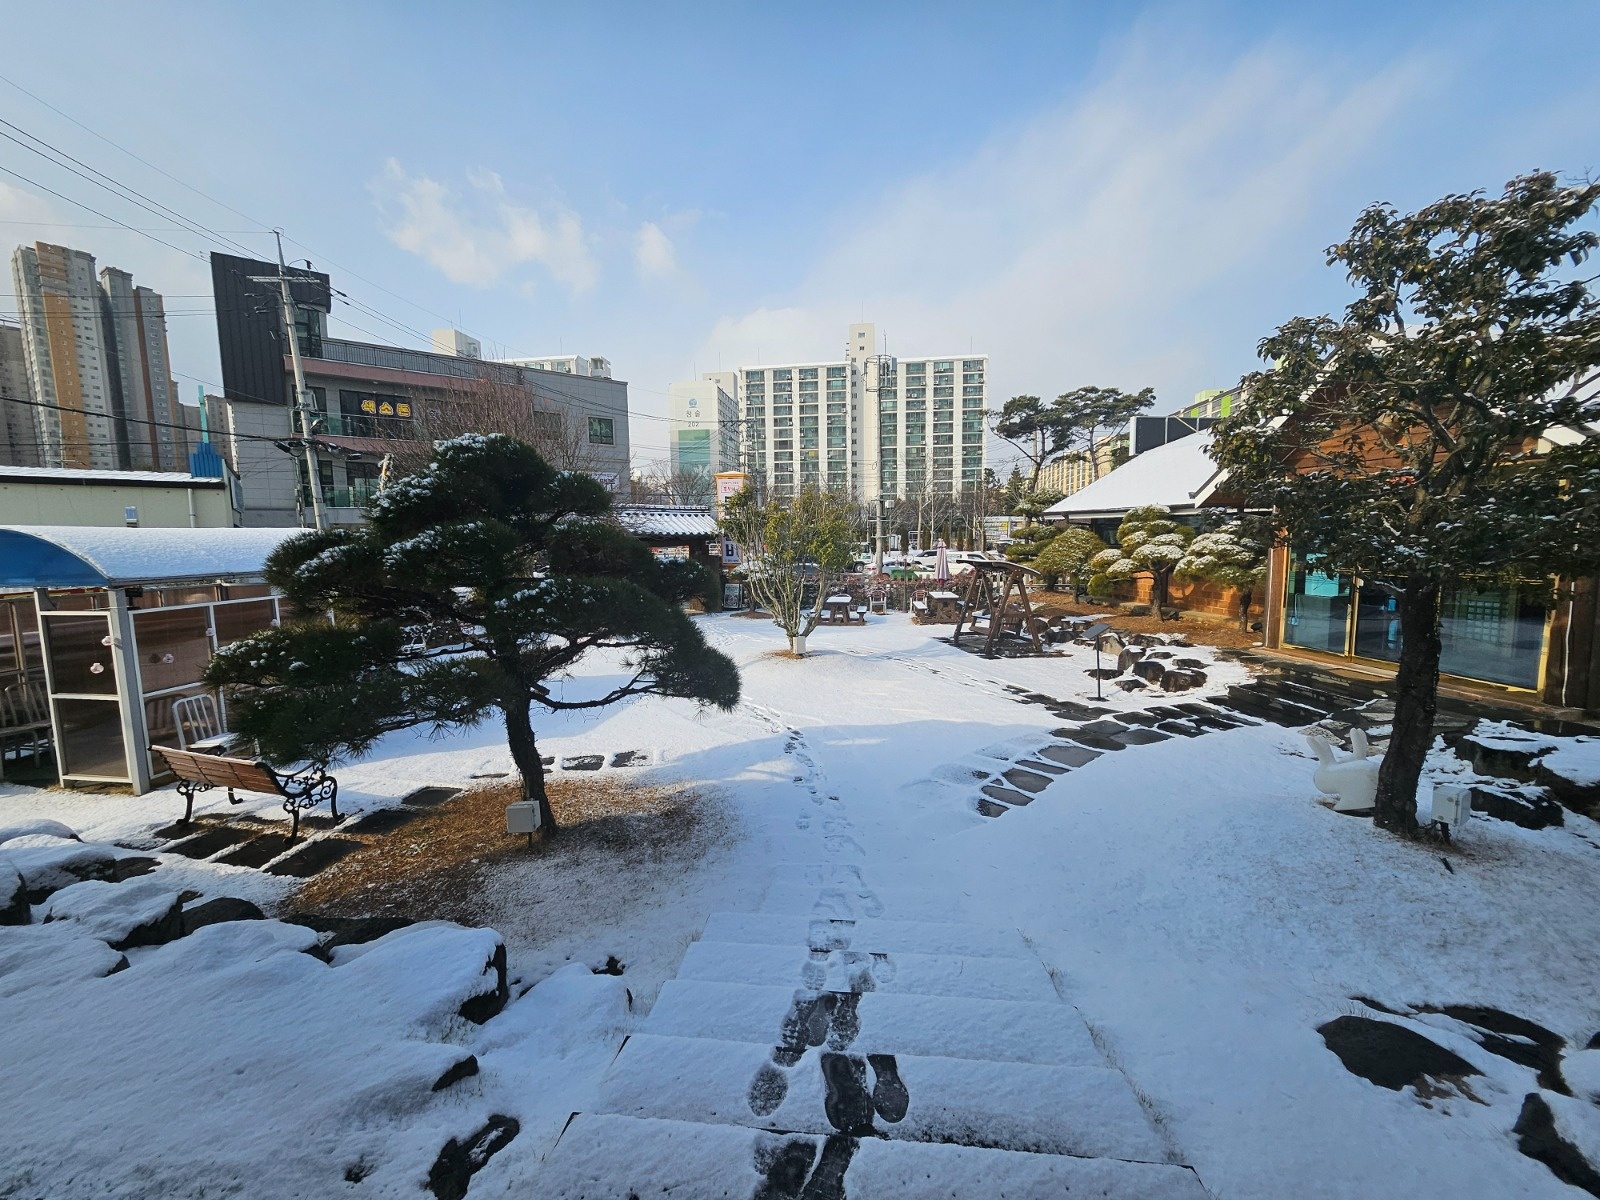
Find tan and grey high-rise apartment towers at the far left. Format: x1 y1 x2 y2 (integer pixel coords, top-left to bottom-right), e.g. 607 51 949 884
6 242 186 470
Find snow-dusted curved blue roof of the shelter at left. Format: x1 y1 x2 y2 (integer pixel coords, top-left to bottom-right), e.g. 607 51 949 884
0 525 299 587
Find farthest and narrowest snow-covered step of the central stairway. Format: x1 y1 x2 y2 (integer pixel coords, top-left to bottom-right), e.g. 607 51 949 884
701 912 1037 962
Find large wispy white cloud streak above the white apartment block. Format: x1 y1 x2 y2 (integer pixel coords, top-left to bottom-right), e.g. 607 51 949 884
696 30 1430 425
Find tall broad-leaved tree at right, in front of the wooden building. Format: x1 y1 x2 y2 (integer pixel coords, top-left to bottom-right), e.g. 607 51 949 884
1213 173 1600 837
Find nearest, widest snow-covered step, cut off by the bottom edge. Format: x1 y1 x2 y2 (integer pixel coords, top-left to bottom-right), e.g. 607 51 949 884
533 1112 1206 1200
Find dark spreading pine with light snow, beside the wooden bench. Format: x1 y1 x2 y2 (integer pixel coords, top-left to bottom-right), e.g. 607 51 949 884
206 434 739 830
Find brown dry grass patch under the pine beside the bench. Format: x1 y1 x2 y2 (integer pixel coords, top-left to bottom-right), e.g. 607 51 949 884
283 776 720 925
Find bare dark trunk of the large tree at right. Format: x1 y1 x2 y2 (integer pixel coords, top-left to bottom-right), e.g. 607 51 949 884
1373 574 1440 837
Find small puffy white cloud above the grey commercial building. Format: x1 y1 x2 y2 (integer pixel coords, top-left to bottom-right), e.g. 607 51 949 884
370 158 600 291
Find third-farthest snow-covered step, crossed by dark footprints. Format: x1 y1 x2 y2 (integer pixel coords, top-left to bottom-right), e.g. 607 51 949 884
640 979 1104 1067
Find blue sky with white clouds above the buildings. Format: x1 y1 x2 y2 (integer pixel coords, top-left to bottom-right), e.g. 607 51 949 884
0 0 1600 472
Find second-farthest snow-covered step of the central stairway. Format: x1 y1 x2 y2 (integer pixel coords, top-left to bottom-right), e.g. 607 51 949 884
678 941 1058 1003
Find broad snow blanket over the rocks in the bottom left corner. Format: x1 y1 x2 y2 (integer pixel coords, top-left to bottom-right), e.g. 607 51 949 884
0 915 524 1200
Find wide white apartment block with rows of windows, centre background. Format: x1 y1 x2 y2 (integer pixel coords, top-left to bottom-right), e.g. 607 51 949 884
738 323 989 499
